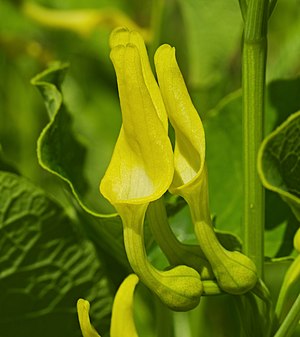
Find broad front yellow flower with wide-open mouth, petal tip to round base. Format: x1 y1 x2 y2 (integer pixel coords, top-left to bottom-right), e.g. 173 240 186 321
100 28 202 310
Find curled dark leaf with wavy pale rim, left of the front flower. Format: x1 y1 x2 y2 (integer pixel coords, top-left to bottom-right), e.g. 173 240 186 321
32 63 115 217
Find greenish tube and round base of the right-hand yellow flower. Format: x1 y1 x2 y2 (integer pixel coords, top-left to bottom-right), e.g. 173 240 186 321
189 166 257 295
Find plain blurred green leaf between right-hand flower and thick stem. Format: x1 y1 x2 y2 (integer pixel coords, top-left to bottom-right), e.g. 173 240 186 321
203 91 242 236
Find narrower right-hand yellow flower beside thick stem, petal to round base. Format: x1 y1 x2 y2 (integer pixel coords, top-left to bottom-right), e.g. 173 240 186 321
155 45 257 294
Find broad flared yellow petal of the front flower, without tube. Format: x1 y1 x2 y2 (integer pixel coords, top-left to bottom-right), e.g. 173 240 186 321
100 44 174 207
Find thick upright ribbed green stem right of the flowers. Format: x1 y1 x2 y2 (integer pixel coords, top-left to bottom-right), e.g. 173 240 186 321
242 0 268 277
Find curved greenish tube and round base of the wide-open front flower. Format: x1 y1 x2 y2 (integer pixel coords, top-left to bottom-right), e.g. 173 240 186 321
122 204 203 311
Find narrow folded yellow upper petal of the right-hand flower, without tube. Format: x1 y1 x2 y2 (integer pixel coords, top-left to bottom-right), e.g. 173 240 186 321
155 44 205 194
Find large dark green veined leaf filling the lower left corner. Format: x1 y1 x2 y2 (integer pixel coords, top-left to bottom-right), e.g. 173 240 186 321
0 172 112 337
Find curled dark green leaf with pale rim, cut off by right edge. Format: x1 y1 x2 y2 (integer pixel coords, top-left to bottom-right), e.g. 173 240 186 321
258 111 300 221
